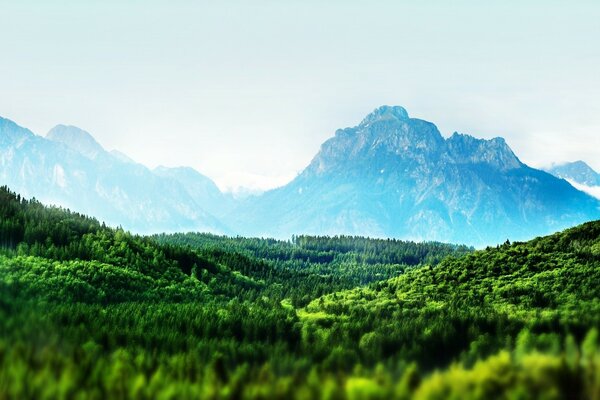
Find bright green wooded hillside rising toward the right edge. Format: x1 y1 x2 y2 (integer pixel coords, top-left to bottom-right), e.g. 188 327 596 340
304 217 600 374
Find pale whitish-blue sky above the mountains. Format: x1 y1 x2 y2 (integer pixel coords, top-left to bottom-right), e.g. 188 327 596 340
0 0 600 190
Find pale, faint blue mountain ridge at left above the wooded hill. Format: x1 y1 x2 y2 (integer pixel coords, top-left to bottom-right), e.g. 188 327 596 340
0 118 229 233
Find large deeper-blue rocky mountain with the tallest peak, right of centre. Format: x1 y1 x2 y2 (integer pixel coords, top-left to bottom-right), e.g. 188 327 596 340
226 106 600 246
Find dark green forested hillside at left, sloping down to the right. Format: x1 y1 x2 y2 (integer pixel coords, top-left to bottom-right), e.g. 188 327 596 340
0 187 221 303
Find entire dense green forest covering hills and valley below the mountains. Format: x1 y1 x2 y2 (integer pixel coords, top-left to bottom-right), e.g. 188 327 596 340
0 188 600 399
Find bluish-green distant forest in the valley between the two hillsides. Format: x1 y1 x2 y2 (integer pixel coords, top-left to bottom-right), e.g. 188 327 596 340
153 233 473 307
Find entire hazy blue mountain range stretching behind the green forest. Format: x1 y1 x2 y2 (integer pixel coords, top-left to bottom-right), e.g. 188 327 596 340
0 106 600 246
